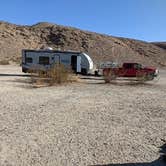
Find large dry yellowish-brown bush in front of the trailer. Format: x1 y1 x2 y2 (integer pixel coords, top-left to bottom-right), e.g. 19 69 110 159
29 64 78 87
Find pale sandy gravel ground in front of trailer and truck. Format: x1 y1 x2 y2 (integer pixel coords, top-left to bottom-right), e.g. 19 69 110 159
0 66 166 166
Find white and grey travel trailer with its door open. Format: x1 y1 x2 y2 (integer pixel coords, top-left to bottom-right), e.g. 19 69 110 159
22 49 94 74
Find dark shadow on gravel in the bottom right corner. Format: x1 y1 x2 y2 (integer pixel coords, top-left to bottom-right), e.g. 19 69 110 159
91 144 166 166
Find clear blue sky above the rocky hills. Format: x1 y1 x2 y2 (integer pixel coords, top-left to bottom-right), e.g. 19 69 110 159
0 0 166 41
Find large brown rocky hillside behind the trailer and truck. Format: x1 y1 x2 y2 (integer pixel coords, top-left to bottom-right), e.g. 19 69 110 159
0 22 166 66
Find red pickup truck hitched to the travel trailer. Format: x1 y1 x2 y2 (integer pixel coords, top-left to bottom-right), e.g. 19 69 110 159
103 63 158 82
